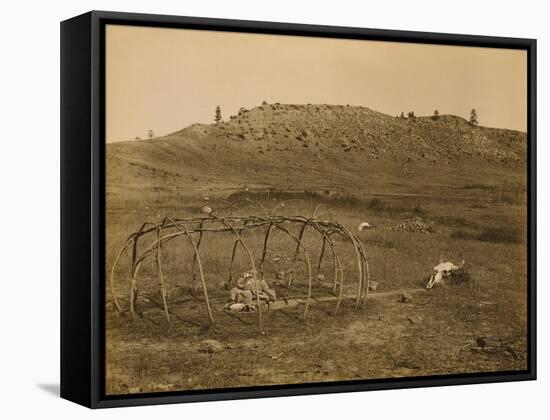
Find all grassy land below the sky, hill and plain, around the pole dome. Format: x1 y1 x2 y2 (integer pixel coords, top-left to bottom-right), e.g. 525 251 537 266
106 104 527 394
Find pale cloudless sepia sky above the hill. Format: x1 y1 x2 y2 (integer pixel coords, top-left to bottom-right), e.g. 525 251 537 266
106 25 527 142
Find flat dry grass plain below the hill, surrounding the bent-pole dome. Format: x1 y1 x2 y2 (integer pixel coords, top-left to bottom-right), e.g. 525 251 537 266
106 176 527 394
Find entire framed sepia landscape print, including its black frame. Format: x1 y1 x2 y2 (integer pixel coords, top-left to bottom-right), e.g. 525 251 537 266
61 12 536 408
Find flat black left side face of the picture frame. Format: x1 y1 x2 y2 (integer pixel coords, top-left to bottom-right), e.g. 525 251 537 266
60 13 93 407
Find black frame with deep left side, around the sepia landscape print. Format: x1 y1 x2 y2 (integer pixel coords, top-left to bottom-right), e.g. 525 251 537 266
61 11 536 408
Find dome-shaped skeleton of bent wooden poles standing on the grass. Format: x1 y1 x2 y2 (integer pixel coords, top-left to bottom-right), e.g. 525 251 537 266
109 217 370 331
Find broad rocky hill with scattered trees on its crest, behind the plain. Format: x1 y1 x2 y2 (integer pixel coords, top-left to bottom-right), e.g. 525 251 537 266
107 104 527 199
